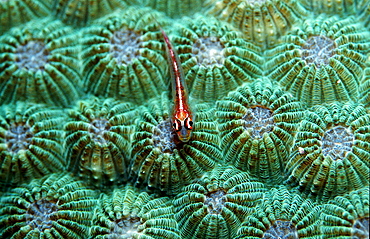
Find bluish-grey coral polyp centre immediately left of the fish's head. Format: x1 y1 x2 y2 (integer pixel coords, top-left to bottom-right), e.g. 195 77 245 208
153 120 176 153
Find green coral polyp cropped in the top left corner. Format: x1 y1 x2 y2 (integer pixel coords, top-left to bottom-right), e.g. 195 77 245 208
0 0 52 34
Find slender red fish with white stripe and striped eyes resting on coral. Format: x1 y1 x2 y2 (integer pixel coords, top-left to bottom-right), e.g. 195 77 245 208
158 21 194 142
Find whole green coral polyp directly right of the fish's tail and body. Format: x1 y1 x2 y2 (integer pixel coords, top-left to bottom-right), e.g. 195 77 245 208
172 15 263 102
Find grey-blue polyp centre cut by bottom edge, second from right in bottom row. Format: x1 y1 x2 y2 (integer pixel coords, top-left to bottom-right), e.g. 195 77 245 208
262 220 298 239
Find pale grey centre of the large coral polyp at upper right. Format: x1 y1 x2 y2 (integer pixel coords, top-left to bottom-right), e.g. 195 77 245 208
301 36 336 68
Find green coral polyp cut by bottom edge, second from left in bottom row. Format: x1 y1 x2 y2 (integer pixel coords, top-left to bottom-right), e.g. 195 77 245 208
91 186 180 239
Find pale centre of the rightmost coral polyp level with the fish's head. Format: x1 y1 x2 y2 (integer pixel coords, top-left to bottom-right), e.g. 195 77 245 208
321 125 354 160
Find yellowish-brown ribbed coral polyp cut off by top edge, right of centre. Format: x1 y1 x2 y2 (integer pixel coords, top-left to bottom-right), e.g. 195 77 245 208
205 0 308 49
